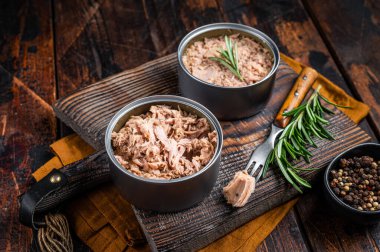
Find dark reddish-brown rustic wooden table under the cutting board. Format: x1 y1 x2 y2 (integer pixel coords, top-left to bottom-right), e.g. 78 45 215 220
0 0 380 251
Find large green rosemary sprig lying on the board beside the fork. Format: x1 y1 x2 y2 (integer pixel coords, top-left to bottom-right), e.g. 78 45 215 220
263 86 350 193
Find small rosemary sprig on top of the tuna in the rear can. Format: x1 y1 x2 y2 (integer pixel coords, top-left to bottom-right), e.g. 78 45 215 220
209 35 244 81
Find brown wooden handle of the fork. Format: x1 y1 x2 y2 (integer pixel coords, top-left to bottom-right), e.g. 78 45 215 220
274 67 318 128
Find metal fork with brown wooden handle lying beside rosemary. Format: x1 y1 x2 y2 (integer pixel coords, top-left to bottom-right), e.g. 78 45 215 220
245 67 318 181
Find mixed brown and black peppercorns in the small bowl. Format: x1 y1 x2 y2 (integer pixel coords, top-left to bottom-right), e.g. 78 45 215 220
329 156 380 211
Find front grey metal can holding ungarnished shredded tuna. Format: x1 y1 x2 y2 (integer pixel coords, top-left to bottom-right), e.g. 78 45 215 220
105 95 223 212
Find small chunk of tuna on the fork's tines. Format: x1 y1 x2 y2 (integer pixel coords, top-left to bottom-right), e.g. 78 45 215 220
223 171 255 207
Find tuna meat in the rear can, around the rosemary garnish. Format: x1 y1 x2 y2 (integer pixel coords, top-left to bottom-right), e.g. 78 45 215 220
182 34 273 87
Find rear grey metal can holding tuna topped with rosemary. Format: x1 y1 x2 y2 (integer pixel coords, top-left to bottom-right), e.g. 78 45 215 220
178 23 280 120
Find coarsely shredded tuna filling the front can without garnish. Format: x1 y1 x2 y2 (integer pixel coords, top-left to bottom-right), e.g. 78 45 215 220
111 105 217 179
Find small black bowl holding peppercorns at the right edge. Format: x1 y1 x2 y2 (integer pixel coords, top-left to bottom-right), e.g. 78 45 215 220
323 143 380 225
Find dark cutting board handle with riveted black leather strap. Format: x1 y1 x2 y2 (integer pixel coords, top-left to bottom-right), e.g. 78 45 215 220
19 150 111 230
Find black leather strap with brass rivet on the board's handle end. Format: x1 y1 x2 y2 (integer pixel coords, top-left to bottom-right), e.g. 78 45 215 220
19 169 68 230
